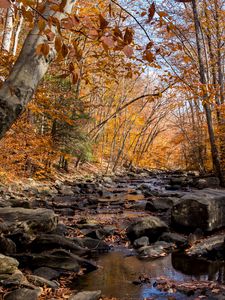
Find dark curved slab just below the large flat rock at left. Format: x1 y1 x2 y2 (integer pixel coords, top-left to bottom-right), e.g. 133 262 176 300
30 233 87 255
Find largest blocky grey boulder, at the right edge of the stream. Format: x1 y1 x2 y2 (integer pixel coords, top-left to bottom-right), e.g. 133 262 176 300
171 189 225 231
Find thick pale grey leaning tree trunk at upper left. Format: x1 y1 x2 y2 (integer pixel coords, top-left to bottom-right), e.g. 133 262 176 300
0 0 75 138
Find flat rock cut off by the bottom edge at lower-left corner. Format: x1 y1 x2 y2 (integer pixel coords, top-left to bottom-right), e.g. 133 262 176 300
4 288 42 300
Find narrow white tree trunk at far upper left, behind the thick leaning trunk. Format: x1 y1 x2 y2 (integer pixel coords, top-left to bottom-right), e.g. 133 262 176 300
2 7 14 52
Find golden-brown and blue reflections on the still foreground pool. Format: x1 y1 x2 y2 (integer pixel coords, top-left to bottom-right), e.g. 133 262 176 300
73 252 213 300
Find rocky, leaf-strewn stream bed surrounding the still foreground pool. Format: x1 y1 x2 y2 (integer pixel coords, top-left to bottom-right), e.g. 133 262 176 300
0 170 225 300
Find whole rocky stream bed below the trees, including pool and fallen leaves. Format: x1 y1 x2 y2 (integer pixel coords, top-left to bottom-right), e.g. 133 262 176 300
0 170 225 300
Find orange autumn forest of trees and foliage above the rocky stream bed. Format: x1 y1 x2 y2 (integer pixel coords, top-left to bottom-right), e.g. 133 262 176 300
0 0 225 183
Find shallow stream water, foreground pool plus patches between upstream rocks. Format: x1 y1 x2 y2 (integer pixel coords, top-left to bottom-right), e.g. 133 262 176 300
67 173 225 300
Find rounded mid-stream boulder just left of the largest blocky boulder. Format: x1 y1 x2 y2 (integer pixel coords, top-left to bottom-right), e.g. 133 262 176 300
127 216 168 242
